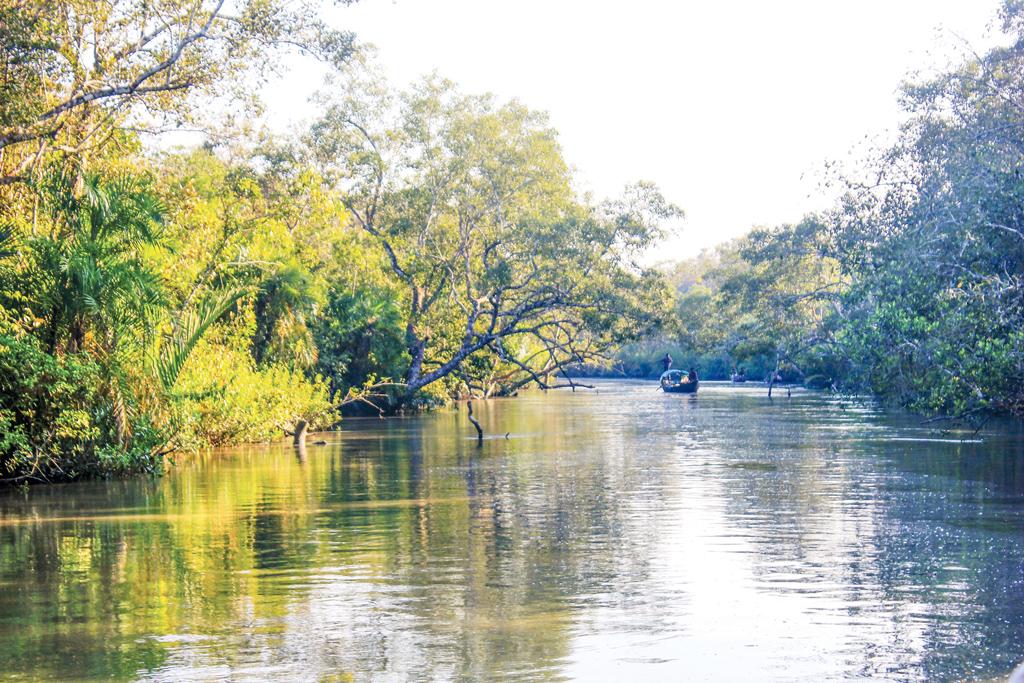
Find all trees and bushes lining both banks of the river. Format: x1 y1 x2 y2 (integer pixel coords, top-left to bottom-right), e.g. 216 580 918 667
0 0 1024 483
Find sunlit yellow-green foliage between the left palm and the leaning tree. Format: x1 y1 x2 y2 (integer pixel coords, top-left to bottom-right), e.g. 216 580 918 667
148 146 352 447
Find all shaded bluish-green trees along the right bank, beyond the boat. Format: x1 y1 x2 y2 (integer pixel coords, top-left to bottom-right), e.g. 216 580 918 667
620 2 1024 417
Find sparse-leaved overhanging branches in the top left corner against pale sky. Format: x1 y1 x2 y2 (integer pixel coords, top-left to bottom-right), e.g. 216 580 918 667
0 0 353 184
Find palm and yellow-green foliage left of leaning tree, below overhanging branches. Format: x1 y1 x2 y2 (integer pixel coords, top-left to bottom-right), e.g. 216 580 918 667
0 155 352 480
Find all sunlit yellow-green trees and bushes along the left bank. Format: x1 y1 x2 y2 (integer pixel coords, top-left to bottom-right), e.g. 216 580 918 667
0 0 680 483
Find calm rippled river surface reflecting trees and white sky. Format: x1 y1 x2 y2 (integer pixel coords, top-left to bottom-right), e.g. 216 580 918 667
0 383 1024 681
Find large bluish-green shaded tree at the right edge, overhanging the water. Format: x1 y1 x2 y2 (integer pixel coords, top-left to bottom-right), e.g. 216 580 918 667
833 2 1024 415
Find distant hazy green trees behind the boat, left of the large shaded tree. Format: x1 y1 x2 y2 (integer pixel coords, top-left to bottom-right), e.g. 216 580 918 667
616 217 845 384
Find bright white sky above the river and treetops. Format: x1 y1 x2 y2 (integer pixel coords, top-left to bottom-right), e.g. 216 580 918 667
265 0 999 260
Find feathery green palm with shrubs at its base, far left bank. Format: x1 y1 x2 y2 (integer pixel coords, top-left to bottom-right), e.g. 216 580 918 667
0 170 164 479
